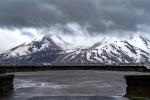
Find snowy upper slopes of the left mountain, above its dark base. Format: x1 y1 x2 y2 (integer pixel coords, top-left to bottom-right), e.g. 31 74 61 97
0 34 70 58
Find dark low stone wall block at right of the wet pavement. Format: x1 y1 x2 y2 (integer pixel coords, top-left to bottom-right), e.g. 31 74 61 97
125 75 150 97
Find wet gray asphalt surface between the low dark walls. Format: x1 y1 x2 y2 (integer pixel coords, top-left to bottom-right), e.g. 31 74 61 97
0 70 148 100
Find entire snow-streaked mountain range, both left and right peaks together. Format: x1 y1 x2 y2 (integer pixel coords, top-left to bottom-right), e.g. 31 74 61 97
0 34 150 64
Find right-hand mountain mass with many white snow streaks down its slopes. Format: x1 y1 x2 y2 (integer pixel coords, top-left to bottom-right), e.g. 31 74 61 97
57 35 150 64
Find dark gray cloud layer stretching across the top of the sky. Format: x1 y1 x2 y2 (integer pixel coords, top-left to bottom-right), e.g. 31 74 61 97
0 0 150 33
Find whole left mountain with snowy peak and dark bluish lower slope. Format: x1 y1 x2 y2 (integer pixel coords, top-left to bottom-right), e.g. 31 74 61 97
0 35 69 64
